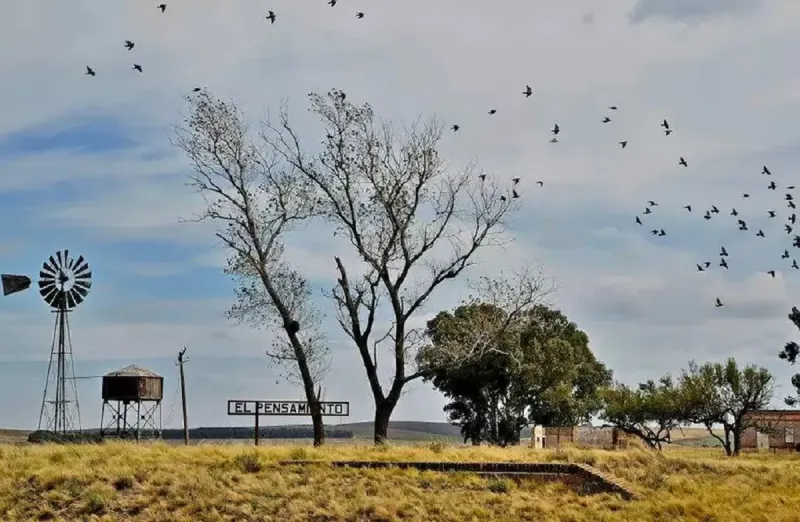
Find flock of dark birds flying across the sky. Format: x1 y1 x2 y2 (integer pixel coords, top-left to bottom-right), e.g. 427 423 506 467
76 5 800 308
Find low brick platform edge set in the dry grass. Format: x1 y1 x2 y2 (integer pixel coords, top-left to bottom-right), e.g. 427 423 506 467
280 460 637 500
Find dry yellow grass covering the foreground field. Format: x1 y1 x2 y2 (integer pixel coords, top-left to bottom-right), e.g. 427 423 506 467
0 442 800 522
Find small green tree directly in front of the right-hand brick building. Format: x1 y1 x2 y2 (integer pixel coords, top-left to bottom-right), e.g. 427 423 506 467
680 358 775 456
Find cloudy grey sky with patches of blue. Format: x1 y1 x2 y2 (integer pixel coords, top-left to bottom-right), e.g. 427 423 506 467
0 0 800 429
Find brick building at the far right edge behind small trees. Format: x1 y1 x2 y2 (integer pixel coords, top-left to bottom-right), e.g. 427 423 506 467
742 410 800 451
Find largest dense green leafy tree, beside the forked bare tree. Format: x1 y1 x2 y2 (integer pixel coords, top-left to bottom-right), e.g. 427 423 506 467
420 303 611 446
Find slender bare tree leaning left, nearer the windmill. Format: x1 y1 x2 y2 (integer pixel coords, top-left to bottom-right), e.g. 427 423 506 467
171 91 327 446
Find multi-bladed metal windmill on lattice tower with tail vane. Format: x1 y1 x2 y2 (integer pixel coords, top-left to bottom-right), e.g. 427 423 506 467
2 250 92 434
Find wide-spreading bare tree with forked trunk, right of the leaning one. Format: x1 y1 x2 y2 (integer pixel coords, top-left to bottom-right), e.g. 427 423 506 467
262 90 519 443
